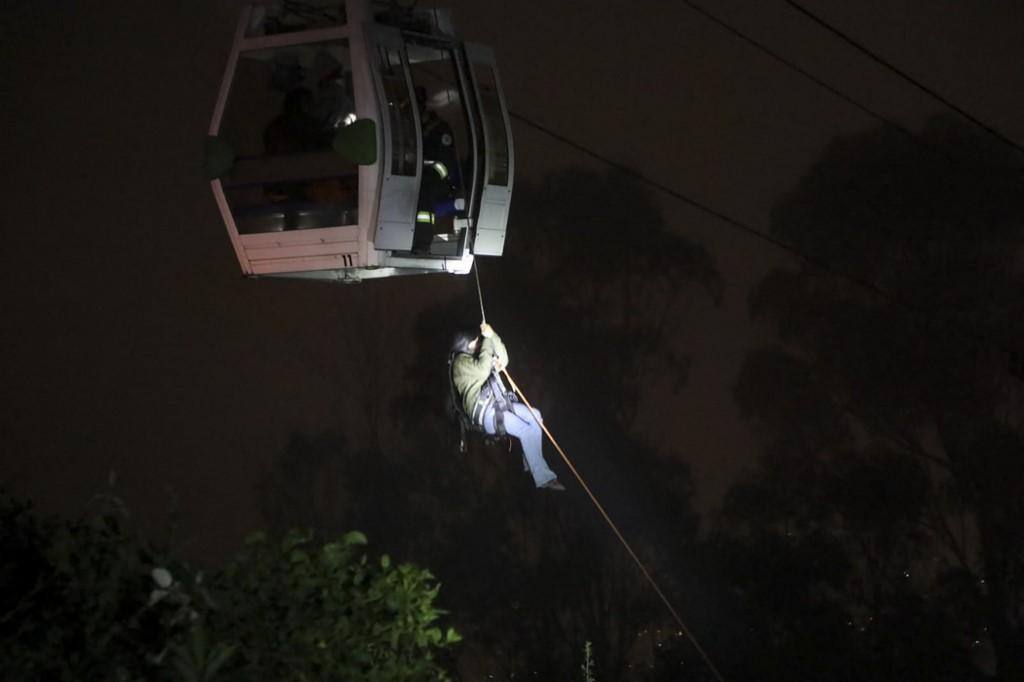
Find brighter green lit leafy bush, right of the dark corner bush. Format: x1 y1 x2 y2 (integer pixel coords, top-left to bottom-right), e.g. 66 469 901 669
210 522 459 682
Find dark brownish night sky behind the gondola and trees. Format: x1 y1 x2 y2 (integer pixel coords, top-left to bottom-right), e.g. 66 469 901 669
0 0 1024 556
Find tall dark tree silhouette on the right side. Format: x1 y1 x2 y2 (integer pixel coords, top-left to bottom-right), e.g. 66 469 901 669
720 119 1024 680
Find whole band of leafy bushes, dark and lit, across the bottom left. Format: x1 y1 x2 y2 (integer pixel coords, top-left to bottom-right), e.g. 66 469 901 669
0 497 460 682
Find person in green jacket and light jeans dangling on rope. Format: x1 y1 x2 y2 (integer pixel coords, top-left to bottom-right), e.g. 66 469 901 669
452 323 565 491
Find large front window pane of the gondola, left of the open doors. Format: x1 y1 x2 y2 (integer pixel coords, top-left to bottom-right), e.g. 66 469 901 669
221 41 358 233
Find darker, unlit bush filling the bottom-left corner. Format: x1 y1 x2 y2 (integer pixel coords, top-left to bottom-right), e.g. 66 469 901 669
0 489 195 680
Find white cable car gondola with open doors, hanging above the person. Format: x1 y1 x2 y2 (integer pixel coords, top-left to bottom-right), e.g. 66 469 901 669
206 0 514 282
